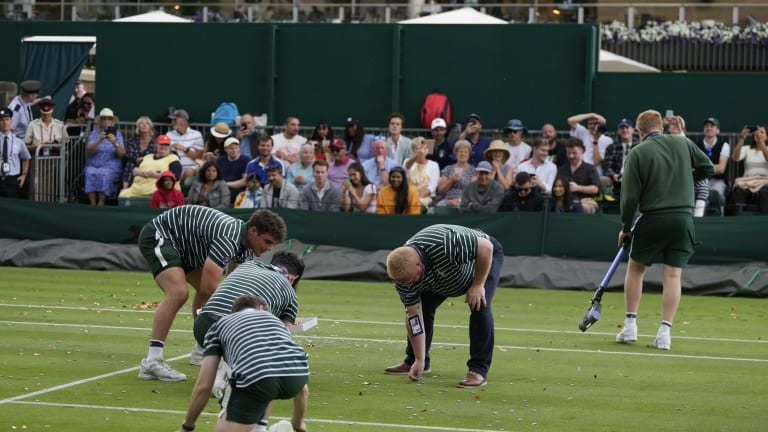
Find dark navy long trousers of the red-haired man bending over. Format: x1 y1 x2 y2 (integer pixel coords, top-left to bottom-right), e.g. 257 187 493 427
405 237 504 377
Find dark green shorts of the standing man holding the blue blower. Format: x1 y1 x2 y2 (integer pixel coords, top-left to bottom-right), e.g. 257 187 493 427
629 210 695 268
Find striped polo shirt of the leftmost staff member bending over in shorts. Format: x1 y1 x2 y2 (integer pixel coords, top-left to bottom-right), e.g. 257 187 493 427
151 205 254 270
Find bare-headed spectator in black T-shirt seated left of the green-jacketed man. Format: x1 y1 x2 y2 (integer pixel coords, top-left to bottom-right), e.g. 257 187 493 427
557 138 600 213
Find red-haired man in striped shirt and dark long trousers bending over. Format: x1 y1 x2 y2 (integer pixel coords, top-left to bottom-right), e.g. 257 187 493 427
384 224 504 387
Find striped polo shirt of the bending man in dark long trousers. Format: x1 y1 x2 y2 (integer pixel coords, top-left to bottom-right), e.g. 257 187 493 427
395 224 488 306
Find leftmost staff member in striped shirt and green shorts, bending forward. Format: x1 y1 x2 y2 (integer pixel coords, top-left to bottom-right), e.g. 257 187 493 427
139 205 287 381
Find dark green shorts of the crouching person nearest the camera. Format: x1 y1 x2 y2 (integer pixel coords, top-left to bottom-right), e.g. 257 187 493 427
227 375 309 424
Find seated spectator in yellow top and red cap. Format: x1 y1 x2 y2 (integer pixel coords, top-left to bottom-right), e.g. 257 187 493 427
118 135 181 199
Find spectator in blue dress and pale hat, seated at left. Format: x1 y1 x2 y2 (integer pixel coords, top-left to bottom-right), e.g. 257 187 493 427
84 108 124 206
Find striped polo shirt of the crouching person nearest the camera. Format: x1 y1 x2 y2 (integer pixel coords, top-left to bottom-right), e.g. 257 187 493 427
203 309 309 388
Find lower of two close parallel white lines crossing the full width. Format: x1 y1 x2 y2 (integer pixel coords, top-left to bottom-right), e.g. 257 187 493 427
0 321 768 363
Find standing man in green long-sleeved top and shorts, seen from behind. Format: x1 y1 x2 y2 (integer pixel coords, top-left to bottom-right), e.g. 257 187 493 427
616 110 715 350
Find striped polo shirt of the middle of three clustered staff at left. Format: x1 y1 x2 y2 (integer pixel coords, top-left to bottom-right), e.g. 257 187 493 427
202 261 299 323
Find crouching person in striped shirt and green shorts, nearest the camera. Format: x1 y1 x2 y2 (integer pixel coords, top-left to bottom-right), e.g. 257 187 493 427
179 295 309 432
